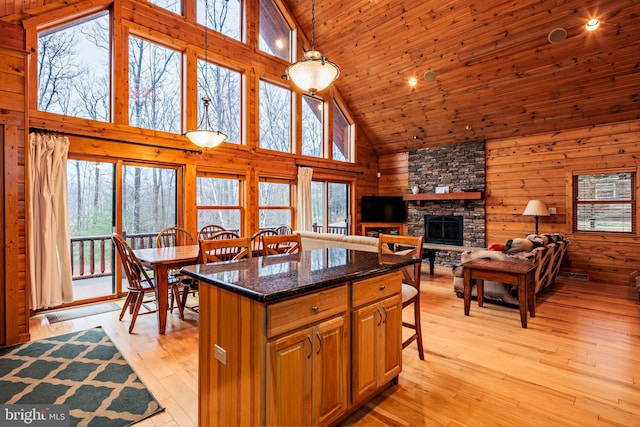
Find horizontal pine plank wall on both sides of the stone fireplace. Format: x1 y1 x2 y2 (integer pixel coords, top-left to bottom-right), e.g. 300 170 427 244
380 121 640 285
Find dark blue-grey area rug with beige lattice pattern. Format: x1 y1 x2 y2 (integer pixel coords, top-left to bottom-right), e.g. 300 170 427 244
0 328 164 427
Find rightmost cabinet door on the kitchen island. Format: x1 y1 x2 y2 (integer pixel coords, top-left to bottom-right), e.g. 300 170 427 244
378 296 402 385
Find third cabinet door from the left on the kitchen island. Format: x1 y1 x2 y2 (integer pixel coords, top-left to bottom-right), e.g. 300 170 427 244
351 304 383 403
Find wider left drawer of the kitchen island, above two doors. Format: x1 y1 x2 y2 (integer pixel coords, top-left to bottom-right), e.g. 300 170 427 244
267 285 348 338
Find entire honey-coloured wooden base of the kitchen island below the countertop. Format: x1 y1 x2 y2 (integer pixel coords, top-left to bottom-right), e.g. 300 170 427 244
198 270 402 426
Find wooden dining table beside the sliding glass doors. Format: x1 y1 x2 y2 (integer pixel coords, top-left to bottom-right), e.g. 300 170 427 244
133 245 200 334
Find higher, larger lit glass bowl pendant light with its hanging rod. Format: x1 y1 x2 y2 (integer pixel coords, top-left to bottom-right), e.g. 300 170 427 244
282 0 340 95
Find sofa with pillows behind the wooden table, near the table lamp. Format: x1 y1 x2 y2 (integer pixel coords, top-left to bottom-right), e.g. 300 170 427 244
453 234 569 306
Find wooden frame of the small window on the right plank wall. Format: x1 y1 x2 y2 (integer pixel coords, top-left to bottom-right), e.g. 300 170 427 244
567 167 639 237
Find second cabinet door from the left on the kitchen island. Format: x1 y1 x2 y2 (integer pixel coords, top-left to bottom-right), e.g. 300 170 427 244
312 316 349 426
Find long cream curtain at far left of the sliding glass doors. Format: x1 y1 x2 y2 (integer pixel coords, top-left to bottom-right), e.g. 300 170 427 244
28 132 73 310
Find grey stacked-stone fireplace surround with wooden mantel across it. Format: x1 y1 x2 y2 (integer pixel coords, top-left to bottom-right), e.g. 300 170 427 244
407 140 486 265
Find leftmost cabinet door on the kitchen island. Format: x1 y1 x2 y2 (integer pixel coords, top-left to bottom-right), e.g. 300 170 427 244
266 328 314 426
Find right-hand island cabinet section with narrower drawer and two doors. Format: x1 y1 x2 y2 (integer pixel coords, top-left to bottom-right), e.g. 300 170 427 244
351 273 402 404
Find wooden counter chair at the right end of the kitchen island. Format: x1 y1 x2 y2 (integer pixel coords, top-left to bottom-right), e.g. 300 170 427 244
378 234 424 360
